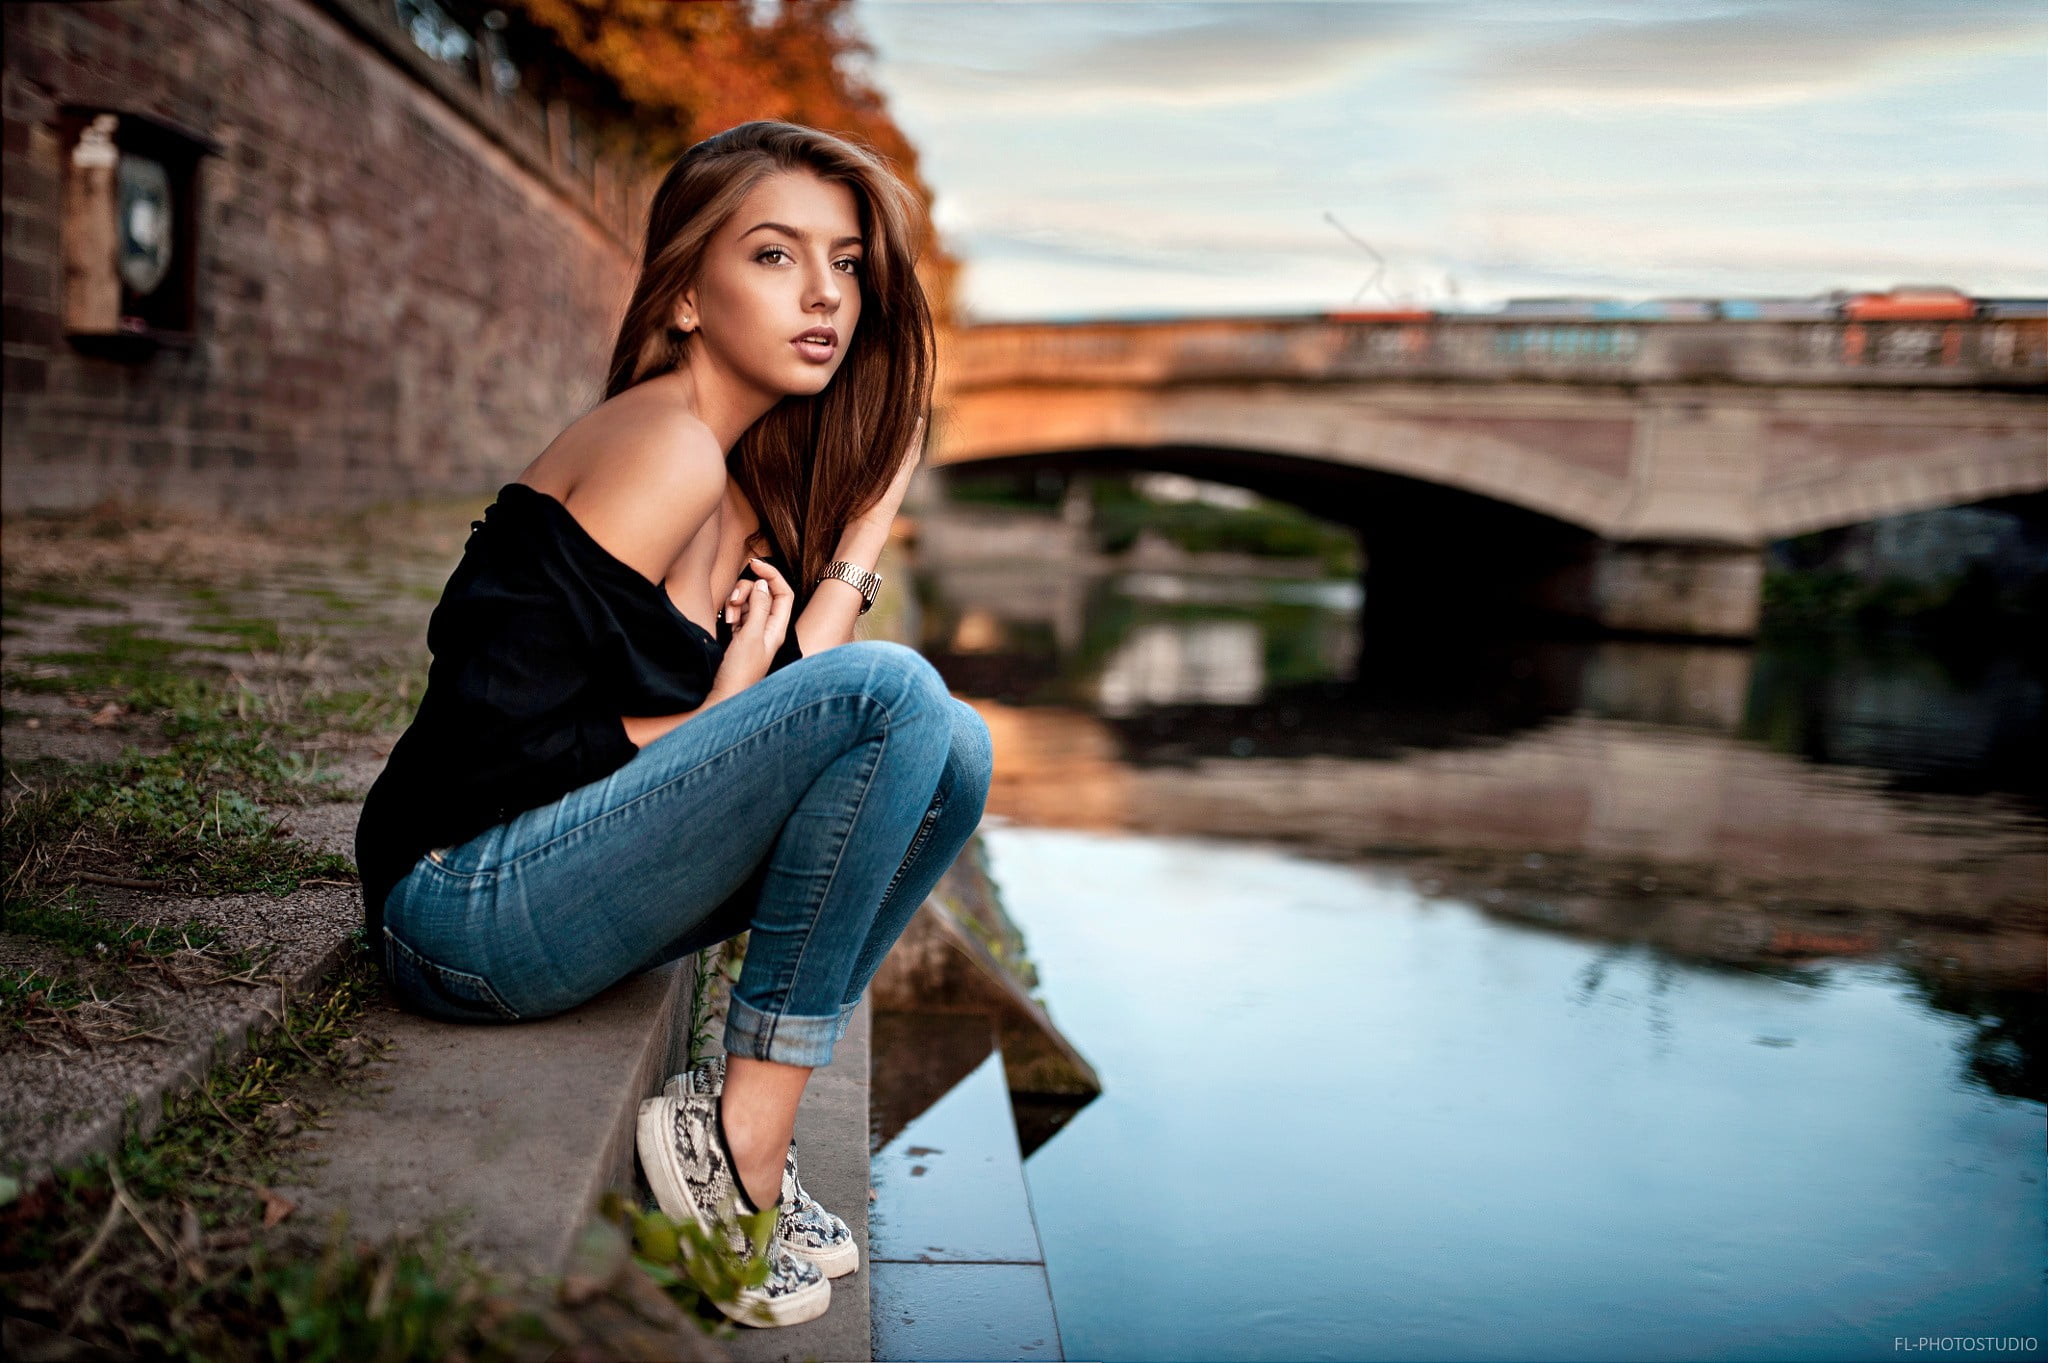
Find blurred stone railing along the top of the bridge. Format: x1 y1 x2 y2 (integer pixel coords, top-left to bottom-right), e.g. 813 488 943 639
944 317 2048 389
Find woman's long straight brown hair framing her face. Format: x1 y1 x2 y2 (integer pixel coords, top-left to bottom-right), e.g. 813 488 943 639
604 119 934 608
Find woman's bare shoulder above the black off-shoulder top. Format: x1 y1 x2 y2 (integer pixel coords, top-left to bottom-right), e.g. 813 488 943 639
561 392 725 583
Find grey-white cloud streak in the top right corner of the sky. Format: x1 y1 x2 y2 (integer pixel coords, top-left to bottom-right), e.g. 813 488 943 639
1468 0 2048 104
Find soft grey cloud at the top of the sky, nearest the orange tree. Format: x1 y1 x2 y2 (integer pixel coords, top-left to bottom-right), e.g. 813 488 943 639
872 2 1419 111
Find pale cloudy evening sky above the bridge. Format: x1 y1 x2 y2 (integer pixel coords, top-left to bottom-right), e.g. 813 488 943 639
852 0 2048 321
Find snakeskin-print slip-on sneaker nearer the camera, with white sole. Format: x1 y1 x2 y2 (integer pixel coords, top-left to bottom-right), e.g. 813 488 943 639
637 1093 831 1326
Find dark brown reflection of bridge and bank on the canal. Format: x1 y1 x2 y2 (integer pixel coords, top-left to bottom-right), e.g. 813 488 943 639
926 540 2048 1006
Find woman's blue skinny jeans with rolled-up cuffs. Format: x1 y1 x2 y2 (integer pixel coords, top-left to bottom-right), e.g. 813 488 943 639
383 639 993 1066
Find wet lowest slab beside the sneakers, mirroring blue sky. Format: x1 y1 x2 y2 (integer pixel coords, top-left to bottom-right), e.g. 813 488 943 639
870 1013 1065 1363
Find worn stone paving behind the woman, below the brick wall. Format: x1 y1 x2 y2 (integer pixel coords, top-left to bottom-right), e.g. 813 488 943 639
0 499 471 1175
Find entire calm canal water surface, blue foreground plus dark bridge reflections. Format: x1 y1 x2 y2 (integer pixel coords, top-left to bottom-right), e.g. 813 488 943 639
901 521 2048 1359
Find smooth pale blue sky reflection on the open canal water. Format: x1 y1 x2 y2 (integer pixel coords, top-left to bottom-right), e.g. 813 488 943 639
985 821 2048 1359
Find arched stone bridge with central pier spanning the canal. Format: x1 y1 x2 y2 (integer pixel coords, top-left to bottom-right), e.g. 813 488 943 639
934 317 2048 636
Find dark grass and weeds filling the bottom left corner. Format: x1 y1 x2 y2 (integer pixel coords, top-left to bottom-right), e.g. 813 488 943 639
0 939 545 1363
